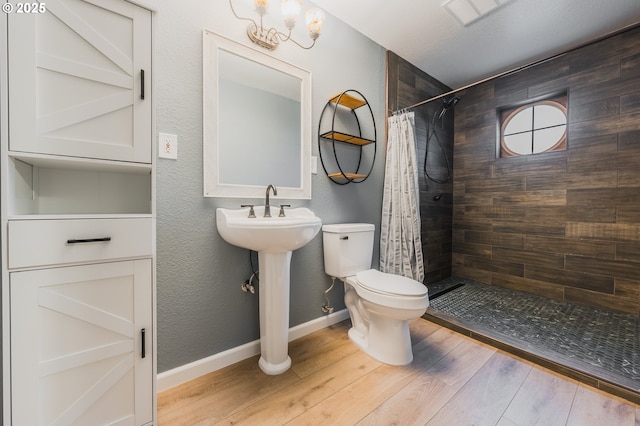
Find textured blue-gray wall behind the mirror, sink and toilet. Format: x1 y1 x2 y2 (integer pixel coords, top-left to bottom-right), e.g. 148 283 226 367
151 0 385 372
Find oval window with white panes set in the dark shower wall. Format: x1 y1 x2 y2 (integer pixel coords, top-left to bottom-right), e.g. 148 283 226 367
500 98 567 157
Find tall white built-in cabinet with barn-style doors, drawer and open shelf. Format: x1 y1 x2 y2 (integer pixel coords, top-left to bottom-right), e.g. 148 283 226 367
0 0 156 426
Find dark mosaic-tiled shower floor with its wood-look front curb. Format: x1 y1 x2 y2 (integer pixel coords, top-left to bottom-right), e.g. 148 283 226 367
423 277 640 404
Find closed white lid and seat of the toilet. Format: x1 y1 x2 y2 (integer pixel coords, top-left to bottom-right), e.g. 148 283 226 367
346 269 429 309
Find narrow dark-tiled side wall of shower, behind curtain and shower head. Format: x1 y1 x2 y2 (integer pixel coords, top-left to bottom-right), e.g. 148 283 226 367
387 52 453 284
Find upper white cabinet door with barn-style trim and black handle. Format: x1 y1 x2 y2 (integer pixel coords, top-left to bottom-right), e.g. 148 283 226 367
8 0 151 163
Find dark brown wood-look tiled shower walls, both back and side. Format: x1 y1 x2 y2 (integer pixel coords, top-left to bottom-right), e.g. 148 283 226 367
388 27 640 315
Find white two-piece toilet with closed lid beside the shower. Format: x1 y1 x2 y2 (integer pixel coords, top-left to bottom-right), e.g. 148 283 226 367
322 223 429 365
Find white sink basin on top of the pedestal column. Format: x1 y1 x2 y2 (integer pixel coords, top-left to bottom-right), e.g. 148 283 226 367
216 206 322 253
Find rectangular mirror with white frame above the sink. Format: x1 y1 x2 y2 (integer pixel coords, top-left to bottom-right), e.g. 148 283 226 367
203 30 311 199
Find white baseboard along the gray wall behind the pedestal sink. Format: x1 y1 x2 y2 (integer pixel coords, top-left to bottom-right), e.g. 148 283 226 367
156 309 349 392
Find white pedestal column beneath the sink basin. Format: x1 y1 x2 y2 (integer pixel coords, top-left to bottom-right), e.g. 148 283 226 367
258 251 291 375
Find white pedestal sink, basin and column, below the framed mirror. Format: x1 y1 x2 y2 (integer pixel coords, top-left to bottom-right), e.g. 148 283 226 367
216 206 322 375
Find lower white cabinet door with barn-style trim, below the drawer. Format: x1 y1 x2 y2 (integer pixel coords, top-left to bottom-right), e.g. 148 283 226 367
10 259 153 425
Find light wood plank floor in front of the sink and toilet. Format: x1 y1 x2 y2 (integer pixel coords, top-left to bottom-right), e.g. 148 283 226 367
158 319 640 426
